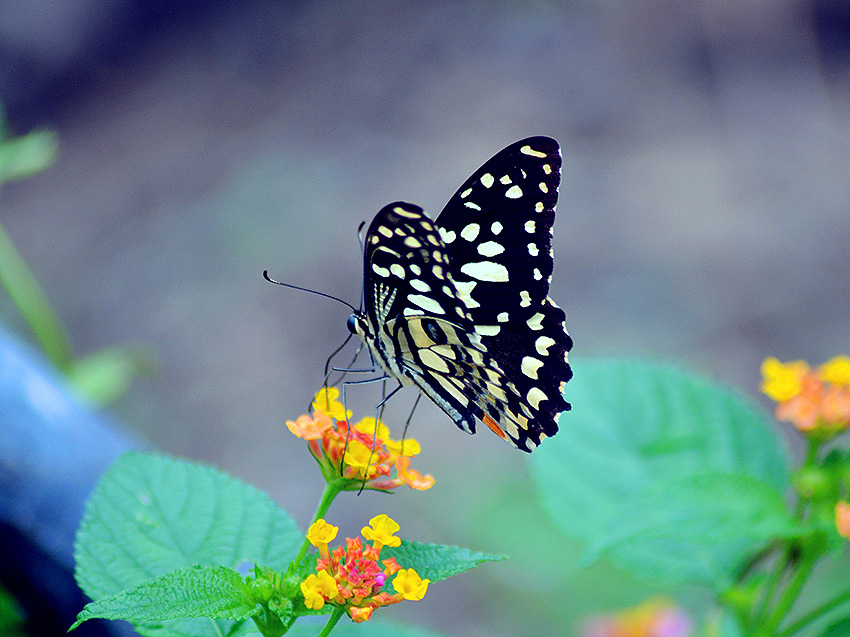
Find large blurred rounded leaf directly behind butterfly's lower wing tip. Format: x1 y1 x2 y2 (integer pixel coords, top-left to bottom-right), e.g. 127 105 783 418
531 359 788 579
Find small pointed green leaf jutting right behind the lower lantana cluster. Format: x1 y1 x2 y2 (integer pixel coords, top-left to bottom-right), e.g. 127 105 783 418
381 540 506 582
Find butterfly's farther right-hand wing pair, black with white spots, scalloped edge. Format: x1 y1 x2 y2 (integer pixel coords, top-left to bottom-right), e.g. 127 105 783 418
436 137 572 443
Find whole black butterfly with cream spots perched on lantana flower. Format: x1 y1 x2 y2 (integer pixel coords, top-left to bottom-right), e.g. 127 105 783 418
348 137 572 452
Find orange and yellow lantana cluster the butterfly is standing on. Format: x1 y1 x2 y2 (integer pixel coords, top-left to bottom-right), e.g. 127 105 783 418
286 387 434 491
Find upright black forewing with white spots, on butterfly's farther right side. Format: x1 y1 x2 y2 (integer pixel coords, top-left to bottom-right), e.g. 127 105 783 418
436 137 561 326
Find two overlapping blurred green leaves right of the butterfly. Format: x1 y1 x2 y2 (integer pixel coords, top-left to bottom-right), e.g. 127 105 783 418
532 359 800 589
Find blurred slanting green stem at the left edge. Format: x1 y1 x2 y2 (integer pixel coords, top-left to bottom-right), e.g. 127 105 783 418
0 219 73 372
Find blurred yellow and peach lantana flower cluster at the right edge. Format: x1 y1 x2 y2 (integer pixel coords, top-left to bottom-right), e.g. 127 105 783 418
761 356 850 438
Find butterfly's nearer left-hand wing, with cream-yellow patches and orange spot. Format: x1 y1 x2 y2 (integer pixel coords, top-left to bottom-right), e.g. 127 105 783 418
354 202 539 451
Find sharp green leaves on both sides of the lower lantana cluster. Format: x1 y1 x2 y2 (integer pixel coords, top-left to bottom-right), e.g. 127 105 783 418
73 453 496 637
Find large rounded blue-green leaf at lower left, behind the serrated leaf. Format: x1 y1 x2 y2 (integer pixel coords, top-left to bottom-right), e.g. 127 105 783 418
75 453 303 637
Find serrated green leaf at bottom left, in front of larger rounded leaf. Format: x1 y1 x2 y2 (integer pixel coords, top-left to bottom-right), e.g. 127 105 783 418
71 566 255 630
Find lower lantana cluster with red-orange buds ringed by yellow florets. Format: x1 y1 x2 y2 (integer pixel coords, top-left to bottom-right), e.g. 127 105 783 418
301 515 430 623
